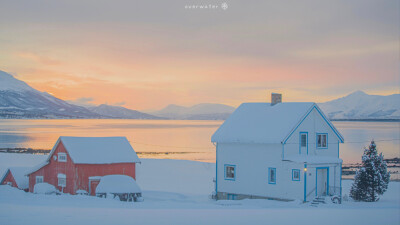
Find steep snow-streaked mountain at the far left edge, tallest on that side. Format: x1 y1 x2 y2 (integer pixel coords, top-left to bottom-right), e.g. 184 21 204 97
0 71 100 118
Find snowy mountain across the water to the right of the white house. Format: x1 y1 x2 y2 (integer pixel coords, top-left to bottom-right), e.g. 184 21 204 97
318 91 400 120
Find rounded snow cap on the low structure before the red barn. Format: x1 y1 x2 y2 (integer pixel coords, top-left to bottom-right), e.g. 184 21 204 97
96 175 142 193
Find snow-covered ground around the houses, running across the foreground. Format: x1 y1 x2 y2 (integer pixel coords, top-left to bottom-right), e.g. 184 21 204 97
0 153 400 225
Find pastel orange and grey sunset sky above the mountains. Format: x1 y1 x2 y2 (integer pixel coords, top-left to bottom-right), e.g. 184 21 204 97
0 0 400 110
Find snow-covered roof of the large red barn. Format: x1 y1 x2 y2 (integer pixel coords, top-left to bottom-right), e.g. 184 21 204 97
52 136 140 164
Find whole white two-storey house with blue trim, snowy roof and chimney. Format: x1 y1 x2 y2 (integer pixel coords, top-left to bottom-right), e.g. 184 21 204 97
211 94 344 201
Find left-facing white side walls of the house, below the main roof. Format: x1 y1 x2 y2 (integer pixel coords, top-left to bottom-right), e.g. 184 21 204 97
217 144 304 199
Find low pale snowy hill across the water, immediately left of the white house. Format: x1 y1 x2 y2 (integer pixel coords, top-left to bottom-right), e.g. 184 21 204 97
151 103 235 120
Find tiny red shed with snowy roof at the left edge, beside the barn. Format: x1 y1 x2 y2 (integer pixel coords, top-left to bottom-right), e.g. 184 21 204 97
0 167 30 191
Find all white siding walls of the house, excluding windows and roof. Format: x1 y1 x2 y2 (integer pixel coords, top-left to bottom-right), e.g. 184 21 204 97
217 108 341 201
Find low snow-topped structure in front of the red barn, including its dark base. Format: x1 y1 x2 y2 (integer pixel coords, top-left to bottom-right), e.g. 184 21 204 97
96 175 142 202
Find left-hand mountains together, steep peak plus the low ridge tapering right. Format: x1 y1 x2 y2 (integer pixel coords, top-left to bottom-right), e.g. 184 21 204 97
0 71 164 119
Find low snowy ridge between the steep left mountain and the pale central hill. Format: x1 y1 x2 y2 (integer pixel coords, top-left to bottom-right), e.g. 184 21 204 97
88 104 163 120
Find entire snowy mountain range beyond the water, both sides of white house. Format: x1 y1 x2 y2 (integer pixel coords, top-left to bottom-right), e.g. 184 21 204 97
0 71 400 120
